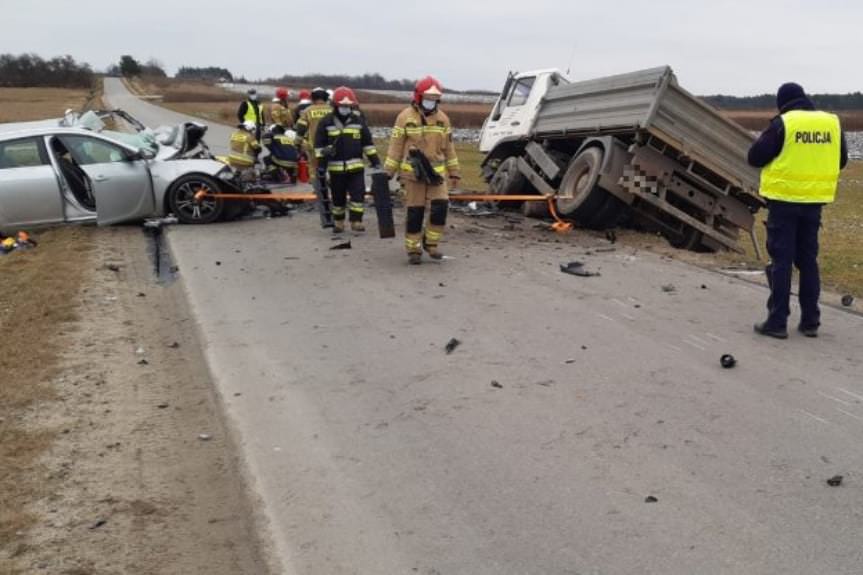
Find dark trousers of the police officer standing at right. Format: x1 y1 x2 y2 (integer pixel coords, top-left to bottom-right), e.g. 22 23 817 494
767 200 822 329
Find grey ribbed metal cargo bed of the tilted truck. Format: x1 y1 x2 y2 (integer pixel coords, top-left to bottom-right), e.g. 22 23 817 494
533 66 759 196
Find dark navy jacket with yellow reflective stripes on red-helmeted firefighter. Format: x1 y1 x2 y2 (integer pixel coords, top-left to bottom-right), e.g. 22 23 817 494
315 112 381 174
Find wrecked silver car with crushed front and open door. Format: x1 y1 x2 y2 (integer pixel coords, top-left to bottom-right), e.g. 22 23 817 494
0 111 235 233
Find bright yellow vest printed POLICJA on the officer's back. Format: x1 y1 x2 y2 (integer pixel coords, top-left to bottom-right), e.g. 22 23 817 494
761 110 842 204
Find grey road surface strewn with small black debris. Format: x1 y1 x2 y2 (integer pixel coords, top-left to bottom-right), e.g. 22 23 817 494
103 77 863 575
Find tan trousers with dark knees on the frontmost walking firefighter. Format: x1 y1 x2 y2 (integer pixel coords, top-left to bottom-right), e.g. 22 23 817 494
402 181 449 254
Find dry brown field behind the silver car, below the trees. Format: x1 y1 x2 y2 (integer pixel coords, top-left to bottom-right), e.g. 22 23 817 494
0 88 95 123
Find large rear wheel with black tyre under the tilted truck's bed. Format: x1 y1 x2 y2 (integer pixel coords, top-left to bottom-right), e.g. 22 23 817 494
557 146 623 229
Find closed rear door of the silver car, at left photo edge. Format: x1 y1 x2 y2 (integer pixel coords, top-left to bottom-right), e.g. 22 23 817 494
0 137 63 231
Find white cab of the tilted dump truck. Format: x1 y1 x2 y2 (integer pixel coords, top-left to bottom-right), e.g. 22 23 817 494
479 68 569 154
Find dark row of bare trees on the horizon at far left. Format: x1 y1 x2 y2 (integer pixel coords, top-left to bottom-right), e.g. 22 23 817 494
0 54 94 88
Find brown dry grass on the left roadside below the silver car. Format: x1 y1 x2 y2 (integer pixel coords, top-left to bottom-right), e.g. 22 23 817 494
0 227 96 552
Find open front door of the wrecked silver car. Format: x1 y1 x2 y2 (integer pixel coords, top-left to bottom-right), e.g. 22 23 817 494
59 134 156 225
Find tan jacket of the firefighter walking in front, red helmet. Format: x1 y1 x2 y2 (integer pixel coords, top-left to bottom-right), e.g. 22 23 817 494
384 105 459 181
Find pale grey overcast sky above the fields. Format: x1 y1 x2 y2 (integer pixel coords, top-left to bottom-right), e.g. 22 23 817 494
0 0 863 95
